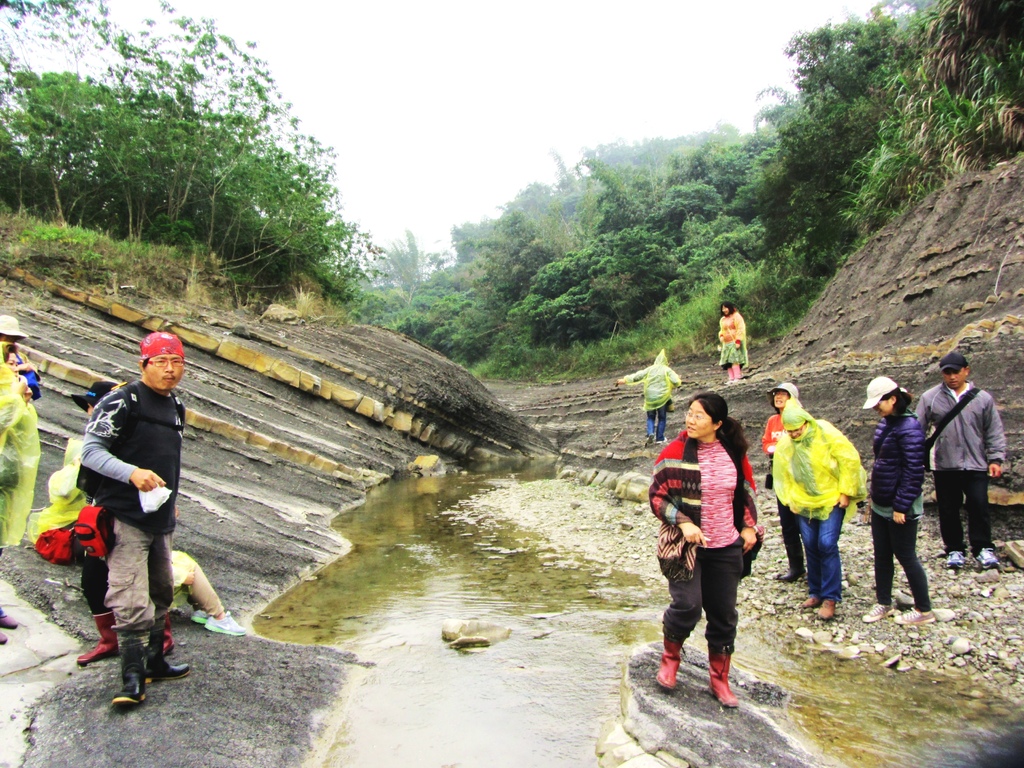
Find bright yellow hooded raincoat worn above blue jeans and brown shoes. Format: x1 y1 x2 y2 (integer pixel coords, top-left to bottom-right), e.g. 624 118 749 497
772 400 867 520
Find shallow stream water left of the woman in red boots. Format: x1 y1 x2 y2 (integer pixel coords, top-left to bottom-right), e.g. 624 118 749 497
256 467 662 768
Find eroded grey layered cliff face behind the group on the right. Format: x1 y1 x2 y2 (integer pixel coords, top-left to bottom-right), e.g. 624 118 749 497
495 161 1024 504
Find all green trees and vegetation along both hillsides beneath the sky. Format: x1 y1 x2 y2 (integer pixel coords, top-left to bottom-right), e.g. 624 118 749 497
0 0 1024 379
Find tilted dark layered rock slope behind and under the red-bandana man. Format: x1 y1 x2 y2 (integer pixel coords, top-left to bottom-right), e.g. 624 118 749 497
0 280 552 768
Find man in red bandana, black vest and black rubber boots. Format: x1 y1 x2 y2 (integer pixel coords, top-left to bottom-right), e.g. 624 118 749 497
82 333 189 706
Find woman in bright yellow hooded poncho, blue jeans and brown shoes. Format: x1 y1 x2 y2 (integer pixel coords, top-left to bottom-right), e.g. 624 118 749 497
772 399 867 621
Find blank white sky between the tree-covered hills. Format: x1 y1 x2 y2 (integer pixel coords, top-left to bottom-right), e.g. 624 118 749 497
99 0 879 251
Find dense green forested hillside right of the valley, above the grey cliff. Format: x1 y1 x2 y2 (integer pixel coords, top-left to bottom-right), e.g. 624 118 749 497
365 0 1024 379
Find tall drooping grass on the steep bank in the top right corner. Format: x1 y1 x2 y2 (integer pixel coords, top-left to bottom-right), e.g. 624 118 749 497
852 0 1024 228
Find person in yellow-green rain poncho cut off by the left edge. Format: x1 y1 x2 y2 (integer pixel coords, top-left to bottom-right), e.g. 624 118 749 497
0 342 39 643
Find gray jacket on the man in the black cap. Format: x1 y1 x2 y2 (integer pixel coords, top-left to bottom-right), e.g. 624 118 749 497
918 382 1007 472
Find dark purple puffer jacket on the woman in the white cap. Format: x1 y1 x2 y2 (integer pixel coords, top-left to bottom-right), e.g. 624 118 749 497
871 411 925 513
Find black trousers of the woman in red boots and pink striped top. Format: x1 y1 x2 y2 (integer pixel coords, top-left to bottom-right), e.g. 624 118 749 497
663 540 743 653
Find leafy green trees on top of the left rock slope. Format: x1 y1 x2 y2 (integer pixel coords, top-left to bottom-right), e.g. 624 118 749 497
0 0 370 304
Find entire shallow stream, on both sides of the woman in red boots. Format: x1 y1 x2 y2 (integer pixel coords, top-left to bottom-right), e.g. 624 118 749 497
255 466 1009 768
